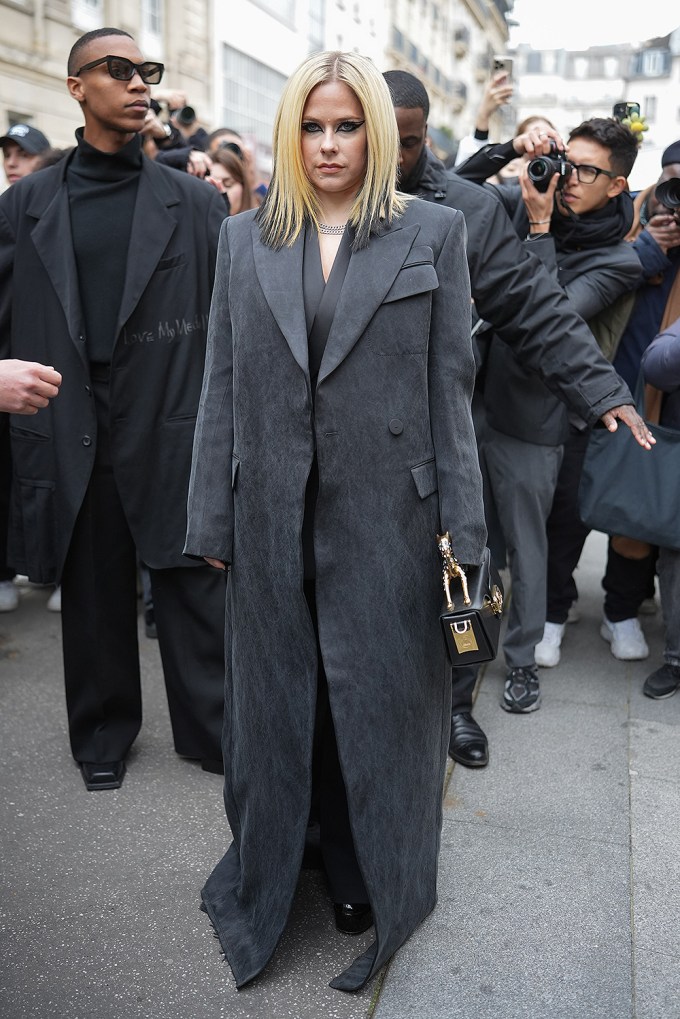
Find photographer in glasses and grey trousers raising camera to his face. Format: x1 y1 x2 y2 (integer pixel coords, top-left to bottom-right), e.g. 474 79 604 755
458 117 641 713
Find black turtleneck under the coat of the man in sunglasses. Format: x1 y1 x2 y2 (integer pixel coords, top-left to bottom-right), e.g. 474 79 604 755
66 127 142 364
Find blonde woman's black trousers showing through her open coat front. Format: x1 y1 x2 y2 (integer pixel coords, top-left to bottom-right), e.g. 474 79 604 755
305 580 368 903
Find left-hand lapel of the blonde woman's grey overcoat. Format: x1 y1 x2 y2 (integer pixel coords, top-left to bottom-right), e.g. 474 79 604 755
252 222 309 375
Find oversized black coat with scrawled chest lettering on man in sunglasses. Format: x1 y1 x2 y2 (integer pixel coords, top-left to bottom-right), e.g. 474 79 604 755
0 150 226 583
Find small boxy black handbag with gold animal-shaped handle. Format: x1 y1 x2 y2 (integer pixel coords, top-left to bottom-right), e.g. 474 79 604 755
436 531 504 665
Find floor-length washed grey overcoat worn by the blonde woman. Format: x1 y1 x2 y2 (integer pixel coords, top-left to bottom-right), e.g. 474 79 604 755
186 196 485 990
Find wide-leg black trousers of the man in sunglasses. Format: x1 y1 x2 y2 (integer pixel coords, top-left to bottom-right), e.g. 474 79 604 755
61 375 225 761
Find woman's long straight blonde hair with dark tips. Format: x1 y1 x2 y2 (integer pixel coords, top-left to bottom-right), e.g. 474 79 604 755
257 52 408 249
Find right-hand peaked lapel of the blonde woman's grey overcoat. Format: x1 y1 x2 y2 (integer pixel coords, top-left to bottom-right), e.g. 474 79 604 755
318 223 420 383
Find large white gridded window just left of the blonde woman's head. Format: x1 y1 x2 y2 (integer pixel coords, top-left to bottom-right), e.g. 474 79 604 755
221 46 285 151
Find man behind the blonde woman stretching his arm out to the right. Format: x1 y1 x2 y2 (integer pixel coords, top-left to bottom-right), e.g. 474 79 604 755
384 71 650 767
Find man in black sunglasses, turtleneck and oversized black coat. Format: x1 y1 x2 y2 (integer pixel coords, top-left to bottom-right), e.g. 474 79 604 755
0 21 230 790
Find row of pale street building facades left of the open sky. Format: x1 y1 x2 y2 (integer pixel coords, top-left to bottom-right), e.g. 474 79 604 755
0 0 512 172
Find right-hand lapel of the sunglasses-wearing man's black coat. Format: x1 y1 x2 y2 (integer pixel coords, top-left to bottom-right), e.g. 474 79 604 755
115 159 178 336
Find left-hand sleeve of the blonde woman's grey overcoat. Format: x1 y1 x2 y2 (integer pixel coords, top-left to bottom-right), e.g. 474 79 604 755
185 219 236 562
